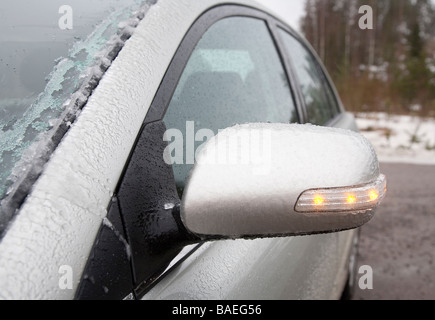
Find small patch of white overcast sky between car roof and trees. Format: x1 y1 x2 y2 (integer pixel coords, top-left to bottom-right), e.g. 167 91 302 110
257 0 305 30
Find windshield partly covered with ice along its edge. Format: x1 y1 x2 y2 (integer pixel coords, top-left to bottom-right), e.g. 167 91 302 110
0 0 144 200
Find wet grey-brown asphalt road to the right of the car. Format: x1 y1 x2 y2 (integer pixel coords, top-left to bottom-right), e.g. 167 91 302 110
354 164 435 300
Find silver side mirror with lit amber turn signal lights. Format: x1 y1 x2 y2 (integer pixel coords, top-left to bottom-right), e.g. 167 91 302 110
181 124 386 239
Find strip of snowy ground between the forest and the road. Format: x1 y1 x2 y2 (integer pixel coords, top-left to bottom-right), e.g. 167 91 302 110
356 113 435 165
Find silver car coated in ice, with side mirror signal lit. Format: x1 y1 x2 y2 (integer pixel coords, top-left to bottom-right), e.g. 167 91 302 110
0 0 386 300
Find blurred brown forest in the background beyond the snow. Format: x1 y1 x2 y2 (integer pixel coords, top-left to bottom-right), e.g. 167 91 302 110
301 0 435 116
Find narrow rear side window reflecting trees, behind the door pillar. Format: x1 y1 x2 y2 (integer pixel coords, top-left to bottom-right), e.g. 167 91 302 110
280 30 338 125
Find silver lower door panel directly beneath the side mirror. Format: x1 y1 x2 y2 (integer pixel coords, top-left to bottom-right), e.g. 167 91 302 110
144 234 349 300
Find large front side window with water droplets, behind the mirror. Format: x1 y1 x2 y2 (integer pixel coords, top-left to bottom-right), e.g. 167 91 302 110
164 17 297 195
